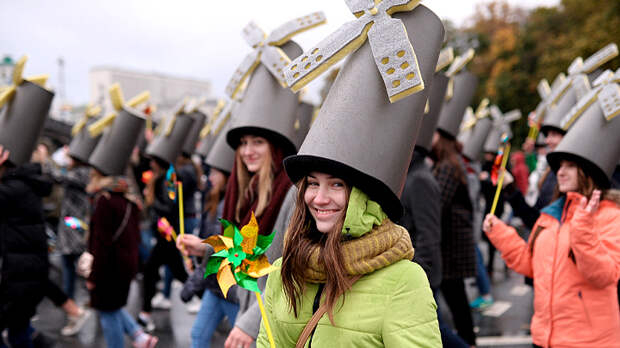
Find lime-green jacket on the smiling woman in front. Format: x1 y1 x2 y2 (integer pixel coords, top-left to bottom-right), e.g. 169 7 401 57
256 259 442 348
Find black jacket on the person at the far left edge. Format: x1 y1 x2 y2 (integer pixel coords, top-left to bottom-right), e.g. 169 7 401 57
0 164 52 328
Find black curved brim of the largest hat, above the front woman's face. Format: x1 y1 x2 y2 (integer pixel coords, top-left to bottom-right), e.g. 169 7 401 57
284 155 403 221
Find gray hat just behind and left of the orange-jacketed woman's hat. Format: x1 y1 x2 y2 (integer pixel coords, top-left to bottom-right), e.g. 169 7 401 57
540 74 590 136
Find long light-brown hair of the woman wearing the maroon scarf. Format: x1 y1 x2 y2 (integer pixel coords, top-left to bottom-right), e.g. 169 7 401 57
235 145 275 221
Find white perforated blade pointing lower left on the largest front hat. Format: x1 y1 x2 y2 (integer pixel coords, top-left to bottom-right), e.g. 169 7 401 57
284 19 372 92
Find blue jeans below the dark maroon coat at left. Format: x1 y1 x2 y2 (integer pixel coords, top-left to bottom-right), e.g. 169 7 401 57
98 308 141 348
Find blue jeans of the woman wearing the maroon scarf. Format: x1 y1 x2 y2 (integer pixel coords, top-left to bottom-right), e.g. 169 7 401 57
192 289 239 348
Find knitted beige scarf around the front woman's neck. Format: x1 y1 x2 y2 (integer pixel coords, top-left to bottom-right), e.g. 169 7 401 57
305 219 413 283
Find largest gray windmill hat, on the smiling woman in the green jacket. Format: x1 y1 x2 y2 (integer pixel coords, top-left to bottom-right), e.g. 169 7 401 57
284 0 444 220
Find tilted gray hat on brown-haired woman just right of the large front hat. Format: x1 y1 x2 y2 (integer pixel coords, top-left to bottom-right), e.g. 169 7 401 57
437 69 478 138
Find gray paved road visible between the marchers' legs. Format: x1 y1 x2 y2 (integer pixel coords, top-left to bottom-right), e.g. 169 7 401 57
27 246 532 348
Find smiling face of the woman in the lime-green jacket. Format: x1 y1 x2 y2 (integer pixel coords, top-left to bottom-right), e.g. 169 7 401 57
304 172 349 233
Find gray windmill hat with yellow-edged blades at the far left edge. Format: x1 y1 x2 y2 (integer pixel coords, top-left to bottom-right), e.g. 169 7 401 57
0 57 54 166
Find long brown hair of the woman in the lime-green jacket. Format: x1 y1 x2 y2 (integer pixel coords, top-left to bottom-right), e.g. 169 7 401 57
280 178 352 325
